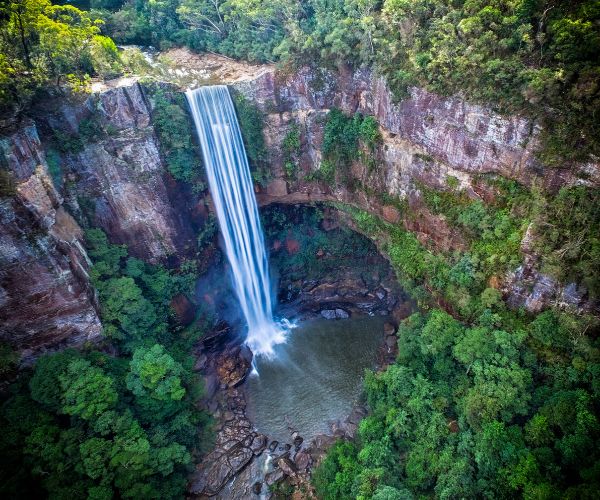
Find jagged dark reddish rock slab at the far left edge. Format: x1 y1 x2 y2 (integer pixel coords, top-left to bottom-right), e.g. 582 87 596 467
0 124 101 362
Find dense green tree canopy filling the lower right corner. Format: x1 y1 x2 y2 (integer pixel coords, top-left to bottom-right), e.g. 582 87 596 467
315 308 600 499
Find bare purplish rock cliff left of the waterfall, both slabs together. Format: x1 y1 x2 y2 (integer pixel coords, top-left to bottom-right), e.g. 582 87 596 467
0 84 198 362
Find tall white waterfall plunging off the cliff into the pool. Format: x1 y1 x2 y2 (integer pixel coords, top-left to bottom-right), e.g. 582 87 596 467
186 85 289 356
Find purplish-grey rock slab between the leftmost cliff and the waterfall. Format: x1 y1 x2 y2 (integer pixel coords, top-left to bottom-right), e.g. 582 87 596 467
47 83 193 263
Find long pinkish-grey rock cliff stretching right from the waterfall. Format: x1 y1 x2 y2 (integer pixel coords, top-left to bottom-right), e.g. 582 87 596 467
235 64 600 312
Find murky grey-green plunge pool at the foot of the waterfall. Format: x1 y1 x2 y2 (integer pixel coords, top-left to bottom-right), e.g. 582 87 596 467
246 316 386 442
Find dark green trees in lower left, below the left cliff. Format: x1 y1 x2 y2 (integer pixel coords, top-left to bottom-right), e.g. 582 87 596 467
0 229 208 499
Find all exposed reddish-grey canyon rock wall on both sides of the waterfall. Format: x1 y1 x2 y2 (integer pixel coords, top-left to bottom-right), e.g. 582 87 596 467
0 59 600 361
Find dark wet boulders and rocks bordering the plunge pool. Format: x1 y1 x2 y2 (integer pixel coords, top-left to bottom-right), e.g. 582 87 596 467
189 239 413 499
